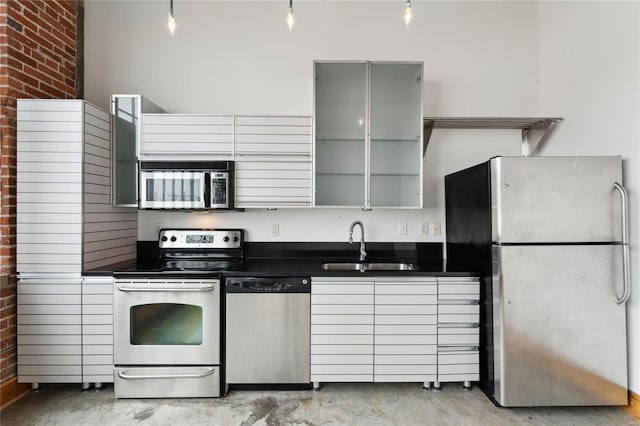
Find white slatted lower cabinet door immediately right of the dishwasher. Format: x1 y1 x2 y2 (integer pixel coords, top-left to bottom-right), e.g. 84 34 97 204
311 278 373 382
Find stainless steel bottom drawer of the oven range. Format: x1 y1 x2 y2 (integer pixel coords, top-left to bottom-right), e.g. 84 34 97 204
113 366 220 398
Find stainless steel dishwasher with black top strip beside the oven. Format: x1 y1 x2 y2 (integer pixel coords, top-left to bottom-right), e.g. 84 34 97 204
224 277 311 389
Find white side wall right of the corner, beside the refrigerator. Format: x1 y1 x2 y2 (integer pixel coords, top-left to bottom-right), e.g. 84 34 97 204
538 1 640 393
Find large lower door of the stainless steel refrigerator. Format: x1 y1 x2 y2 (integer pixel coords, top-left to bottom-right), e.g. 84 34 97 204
492 245 627 407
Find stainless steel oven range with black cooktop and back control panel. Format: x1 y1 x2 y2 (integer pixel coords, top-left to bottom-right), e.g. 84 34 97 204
114 229 243 398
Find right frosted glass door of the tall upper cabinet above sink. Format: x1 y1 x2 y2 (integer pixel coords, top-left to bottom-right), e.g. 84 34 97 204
370 63 422 207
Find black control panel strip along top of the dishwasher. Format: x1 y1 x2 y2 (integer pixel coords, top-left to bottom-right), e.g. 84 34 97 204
225 277 311 293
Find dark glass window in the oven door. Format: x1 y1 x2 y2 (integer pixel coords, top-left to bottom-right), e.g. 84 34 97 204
130 303 203 345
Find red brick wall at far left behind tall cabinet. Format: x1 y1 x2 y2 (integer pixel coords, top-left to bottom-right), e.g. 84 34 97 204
0 0 78 382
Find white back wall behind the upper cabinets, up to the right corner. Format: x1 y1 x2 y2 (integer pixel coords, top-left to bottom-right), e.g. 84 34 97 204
85 0 537 241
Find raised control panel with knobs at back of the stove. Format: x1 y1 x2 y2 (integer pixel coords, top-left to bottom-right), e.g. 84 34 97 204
158 229 243 249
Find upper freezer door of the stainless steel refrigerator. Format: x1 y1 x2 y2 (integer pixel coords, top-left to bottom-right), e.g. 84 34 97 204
491 157 622 243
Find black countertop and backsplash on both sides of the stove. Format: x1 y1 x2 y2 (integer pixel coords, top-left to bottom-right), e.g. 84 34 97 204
83 241 477 277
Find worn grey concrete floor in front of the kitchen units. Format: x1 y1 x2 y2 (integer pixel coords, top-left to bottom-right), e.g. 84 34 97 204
0 383 640 426
